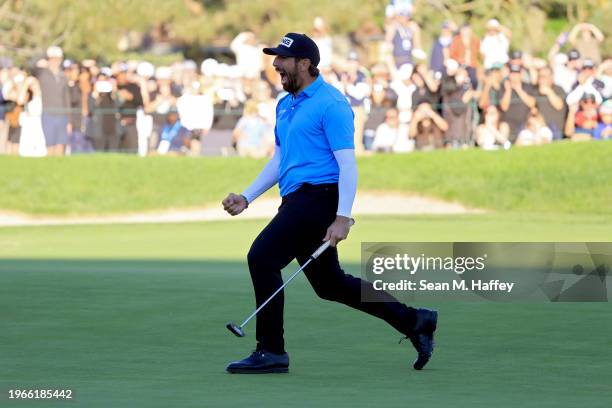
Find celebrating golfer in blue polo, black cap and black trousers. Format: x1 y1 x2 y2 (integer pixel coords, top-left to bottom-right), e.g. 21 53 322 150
223 33 437 374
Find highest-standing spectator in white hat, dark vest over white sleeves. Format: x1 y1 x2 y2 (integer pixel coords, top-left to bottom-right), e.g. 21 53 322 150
385 7 421 68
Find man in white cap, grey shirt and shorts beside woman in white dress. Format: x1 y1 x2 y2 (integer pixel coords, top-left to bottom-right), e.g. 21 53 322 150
36 45 70 156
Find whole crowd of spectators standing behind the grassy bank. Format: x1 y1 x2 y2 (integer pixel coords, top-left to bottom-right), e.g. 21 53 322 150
0 1 612 157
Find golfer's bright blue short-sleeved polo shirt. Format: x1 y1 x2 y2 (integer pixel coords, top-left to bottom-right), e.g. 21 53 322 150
274 75 355 197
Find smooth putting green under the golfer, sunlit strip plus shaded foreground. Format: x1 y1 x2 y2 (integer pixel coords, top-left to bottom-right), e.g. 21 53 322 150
0 214 612 408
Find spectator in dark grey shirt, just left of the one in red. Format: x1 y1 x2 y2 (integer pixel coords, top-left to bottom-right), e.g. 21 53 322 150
536 66 567 140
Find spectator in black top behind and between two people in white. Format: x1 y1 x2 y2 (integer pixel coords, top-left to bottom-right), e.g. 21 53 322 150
500 65 536 143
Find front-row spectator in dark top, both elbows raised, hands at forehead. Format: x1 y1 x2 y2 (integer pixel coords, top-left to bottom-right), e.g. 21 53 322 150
409 101 448 150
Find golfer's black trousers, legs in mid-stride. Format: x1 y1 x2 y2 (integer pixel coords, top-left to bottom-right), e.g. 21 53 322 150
248 184 415 353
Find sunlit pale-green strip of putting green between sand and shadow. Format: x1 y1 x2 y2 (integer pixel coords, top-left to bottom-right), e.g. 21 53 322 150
0 214 612 262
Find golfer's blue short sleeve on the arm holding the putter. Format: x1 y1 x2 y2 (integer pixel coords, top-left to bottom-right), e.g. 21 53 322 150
323 101 355 151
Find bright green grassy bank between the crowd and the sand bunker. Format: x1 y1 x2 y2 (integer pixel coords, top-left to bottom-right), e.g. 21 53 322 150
0 143 612 215
